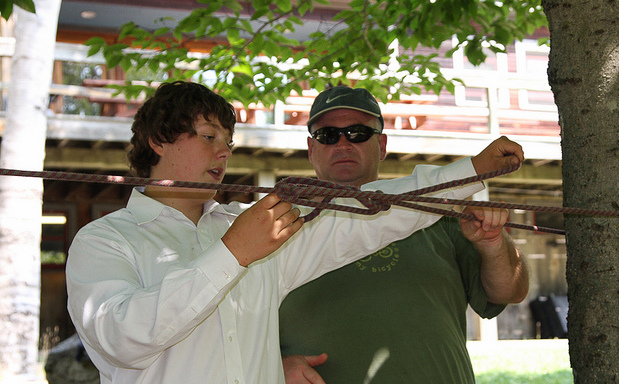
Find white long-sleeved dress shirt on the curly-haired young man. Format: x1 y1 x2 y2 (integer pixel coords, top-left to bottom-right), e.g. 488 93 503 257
66 159 481 384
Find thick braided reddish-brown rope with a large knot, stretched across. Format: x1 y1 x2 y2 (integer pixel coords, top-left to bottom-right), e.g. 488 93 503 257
0 165 619 234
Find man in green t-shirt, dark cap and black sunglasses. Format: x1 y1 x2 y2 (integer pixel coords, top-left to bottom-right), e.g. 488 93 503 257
280 87 528 384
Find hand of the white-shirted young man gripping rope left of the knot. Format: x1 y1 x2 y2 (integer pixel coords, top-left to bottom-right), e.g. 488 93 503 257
221 194 303 267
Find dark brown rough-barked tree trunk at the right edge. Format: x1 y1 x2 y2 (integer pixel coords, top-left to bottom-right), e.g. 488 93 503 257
542 0 619 384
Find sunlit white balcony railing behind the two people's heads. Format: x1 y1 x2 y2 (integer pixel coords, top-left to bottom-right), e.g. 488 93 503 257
0 38 561 160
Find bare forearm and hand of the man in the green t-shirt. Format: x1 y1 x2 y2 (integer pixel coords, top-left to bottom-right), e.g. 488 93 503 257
460 207 529 304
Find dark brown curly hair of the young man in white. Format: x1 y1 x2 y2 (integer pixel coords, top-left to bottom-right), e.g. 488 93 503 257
127 81 236 177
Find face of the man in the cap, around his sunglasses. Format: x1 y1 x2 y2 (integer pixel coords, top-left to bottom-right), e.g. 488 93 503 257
307 109 387 187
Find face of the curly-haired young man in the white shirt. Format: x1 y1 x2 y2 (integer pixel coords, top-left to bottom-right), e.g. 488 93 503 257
151 116 232 200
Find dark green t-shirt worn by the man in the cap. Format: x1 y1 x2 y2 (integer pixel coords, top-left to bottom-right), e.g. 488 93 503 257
280 217 505 384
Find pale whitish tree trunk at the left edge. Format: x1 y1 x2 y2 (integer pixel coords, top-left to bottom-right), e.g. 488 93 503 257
0 0 60 378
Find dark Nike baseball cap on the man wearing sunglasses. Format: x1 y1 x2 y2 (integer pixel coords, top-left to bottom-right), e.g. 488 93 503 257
307 85 385 130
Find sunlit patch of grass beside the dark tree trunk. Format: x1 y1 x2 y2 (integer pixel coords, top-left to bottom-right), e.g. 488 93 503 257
468 339 574 384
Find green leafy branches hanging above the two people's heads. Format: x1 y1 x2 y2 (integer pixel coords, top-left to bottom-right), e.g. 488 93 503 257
86 0 546 105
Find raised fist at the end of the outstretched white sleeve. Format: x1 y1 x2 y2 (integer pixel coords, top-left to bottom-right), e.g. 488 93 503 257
471 136 524 175
